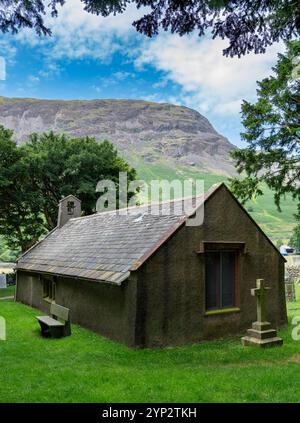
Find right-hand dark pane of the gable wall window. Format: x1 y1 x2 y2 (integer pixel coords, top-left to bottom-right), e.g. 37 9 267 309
221 252 235 307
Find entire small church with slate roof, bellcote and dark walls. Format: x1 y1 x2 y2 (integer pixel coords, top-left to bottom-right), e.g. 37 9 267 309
16 183 287 347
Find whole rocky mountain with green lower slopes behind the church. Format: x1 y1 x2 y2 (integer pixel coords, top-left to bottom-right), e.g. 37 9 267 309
0 97 296 248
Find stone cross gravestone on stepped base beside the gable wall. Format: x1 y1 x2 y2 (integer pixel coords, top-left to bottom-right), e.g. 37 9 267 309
242 279 283 347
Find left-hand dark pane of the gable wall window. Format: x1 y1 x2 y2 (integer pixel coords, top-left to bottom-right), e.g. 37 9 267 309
205 252 220 310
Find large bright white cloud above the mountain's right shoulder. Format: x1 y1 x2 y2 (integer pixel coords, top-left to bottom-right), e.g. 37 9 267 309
135 34 283 115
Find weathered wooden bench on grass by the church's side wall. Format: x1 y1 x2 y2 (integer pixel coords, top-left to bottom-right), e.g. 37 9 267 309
36 303 71 338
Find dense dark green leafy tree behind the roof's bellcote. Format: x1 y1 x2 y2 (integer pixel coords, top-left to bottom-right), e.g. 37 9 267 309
0 127 136 251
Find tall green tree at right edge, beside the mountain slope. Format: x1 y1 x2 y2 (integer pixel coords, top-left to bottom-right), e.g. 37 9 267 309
231 41 300 214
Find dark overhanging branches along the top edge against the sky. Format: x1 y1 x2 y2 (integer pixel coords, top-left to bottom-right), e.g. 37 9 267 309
0 0 300 56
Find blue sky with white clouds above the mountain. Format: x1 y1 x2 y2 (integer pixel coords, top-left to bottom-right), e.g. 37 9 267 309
0 0 283 146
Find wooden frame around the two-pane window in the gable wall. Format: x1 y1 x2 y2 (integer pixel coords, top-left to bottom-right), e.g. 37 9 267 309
204 247 241 315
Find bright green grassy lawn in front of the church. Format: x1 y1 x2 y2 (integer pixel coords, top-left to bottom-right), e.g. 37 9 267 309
0 287 300 402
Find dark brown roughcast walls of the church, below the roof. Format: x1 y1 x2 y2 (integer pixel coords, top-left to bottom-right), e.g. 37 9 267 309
16 187 287 347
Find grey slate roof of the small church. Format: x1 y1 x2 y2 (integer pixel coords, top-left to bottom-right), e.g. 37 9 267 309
17 185 220 285
